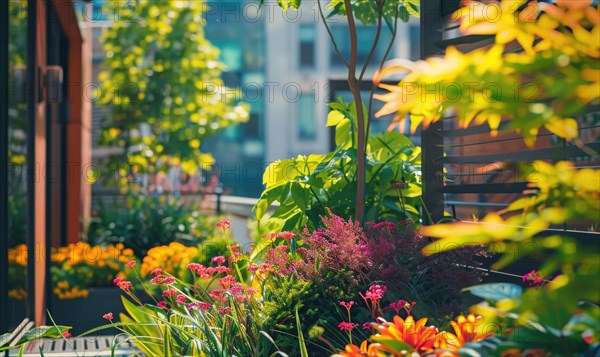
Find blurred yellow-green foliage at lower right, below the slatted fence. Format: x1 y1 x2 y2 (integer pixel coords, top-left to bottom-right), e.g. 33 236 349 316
422 162 600 353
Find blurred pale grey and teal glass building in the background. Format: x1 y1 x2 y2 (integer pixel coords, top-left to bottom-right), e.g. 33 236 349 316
90 0 419 197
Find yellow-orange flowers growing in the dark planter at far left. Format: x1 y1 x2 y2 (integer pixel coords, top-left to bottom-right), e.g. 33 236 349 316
8 242 135 299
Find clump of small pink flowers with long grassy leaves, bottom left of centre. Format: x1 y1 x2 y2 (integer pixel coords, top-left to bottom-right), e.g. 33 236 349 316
104 224 276 356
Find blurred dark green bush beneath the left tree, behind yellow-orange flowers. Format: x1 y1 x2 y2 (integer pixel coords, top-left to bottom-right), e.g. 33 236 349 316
86 192 218 257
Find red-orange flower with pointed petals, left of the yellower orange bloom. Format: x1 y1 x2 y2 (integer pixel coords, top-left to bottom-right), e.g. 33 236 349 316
373 316 438 352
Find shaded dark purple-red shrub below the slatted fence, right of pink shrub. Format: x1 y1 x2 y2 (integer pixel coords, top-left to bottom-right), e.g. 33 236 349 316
365 222 487 316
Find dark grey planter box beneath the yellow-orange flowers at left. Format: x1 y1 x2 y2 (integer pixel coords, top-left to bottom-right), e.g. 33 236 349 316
48 287 132 336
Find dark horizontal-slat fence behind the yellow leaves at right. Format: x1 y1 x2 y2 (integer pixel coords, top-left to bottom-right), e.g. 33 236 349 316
421 0 600 282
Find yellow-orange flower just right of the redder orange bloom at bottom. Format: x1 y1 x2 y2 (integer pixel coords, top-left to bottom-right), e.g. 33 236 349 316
435 314 493 350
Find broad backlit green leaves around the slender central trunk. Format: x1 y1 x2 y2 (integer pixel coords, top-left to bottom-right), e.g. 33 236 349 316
255 99 421 230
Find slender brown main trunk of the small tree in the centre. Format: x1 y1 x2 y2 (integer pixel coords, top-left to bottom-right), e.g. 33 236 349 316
344 0 366 226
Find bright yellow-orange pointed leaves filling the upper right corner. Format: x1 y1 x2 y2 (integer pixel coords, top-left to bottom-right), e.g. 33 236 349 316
376 0 600 145
